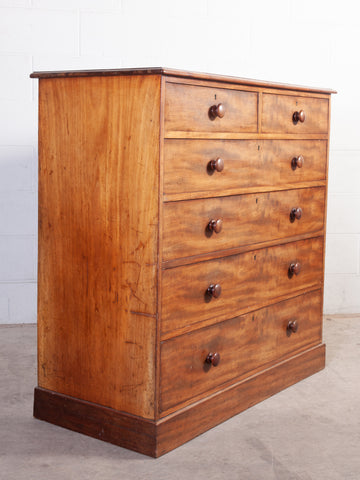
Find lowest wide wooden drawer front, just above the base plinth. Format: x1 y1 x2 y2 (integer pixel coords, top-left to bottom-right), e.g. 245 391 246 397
160 290 322 411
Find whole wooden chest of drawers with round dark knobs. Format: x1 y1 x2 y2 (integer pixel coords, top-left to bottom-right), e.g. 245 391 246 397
32 68 333 456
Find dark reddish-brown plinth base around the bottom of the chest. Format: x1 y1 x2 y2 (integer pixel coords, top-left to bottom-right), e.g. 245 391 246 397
34 345 325 457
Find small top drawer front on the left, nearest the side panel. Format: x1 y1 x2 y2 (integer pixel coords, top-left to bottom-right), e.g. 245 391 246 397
165 83 258 136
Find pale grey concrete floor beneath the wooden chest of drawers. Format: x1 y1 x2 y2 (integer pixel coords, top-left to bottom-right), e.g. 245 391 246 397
0 317 360 480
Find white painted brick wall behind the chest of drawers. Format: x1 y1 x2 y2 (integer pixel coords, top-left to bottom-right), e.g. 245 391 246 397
0 0 360 323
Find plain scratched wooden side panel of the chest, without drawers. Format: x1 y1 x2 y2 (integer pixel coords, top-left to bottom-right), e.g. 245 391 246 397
38 76 160 418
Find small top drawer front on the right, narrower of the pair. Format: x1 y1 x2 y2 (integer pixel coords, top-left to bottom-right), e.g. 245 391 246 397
262 94 329 134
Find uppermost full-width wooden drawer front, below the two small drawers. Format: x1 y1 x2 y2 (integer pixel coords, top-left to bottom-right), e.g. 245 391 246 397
164 139 327 198
